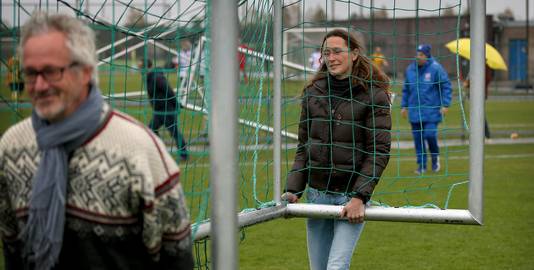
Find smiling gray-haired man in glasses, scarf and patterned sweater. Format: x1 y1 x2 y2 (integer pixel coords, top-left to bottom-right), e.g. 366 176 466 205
0 13 193 270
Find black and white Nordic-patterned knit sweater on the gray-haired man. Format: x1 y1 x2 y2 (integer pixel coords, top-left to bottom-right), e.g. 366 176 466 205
0 104 193 269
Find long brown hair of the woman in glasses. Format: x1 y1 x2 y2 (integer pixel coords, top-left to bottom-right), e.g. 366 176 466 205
308 29 390 91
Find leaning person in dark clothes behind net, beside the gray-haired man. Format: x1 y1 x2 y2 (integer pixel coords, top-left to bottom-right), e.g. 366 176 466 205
138 59 188 160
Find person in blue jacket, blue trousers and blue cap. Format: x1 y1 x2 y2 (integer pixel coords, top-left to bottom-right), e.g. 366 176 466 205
401 44 452 174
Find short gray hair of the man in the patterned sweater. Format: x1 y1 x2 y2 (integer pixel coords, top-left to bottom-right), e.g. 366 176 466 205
19 12 98 84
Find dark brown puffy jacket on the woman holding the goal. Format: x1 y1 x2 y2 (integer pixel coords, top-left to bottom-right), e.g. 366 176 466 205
286 78 391 202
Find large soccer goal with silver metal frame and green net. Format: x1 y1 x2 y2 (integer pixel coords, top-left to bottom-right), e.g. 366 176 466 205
0 0 486 269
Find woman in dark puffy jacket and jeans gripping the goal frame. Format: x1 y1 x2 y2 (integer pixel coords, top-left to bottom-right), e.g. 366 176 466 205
283 30 391 270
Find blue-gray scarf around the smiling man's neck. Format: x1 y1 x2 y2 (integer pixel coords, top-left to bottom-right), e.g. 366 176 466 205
20 87 104 269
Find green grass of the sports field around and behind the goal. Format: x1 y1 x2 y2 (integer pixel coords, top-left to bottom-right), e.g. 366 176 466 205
0 73 534 269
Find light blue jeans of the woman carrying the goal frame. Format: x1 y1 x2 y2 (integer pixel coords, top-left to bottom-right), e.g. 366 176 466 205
306 188 364 270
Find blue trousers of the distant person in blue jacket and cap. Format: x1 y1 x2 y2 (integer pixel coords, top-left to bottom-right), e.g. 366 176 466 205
411 122 439 170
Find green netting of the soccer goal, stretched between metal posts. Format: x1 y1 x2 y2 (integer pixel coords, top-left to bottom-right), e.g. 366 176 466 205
0 0 474 269
